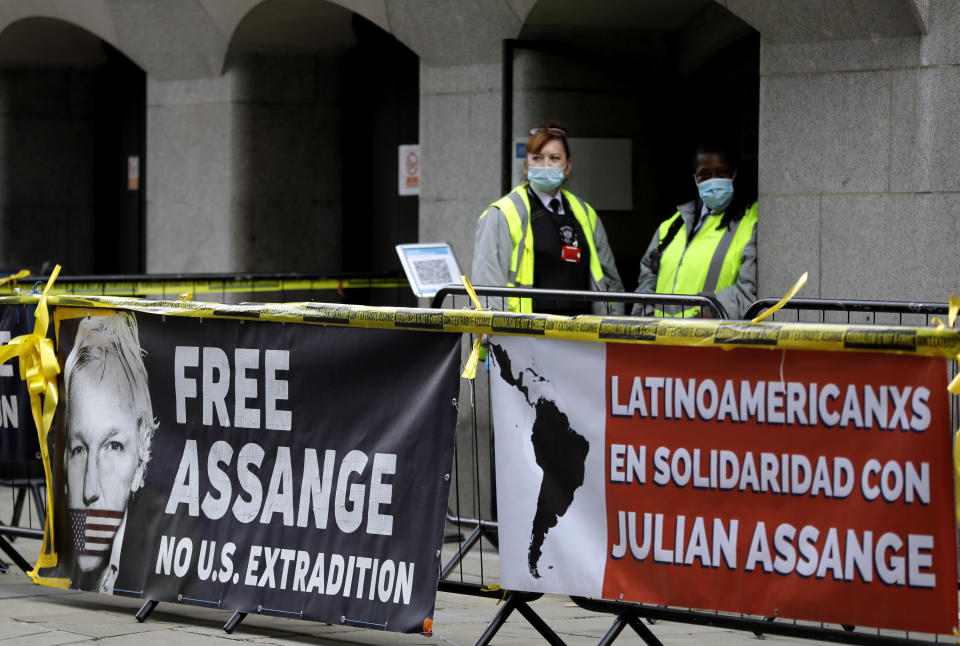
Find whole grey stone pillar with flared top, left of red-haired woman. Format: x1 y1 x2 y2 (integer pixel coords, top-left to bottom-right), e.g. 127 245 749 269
387 0 532 529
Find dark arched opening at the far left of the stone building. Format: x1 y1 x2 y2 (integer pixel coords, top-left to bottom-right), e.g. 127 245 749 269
0 17 146 274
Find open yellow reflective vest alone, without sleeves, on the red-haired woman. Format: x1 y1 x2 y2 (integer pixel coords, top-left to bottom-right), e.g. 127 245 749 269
480 185 603 313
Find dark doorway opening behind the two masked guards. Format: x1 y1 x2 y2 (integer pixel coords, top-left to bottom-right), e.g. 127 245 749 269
504 0 760 291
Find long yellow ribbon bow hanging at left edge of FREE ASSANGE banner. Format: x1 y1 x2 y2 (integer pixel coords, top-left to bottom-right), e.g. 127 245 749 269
0 265 70 588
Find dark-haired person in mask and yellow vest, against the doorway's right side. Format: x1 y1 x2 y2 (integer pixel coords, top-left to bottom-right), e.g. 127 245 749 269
632 143 757 318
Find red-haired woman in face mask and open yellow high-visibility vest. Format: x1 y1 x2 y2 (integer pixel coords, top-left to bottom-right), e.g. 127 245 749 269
470 121 624 316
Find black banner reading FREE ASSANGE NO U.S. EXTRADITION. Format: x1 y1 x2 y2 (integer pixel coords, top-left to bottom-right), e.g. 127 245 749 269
43 308 460 632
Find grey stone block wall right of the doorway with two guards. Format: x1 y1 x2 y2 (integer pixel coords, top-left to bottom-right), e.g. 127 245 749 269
729 0 960 301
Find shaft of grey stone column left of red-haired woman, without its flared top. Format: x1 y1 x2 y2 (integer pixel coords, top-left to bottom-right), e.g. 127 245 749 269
420 62 502 518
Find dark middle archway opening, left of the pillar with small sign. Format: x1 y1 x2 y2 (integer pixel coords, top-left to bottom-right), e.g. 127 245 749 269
225 0 419 272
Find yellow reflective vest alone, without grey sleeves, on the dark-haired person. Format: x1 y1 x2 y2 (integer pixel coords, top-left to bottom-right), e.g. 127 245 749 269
657 202 757 316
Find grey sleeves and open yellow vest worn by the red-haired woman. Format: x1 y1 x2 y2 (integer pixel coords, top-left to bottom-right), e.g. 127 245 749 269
470 184 623 314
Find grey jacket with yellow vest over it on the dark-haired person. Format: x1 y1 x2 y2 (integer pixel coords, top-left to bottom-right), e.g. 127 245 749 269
634 201 757 318
